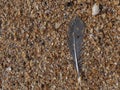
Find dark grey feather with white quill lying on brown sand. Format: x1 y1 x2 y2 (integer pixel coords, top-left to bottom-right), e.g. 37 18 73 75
68 16 85 78
